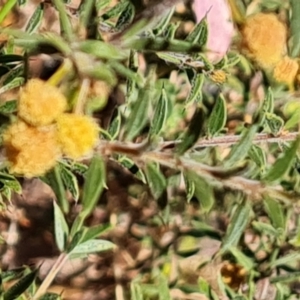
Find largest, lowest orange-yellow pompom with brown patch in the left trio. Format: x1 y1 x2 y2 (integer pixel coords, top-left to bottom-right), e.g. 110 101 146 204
3 120 61 178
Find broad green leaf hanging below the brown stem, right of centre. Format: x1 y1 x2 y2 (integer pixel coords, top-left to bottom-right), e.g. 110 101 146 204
185 171 215 212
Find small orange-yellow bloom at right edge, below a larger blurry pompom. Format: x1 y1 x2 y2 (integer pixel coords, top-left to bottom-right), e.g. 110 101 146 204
273 56 299 87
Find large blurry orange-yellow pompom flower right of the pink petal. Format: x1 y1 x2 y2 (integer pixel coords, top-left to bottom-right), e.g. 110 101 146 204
242 13 287 68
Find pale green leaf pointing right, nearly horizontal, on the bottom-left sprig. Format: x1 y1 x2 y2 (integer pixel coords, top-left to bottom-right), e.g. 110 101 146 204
69 239 115 259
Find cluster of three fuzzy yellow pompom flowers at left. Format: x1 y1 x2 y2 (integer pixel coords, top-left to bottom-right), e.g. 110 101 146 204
3 79 98 177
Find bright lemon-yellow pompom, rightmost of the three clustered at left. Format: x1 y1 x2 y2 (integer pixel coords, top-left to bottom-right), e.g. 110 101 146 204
57 114 98 159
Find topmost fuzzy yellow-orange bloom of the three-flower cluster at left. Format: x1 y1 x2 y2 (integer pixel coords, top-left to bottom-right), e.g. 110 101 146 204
18 79 67 126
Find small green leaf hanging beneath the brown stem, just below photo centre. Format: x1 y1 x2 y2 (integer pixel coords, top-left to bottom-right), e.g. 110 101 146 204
145 163 167 200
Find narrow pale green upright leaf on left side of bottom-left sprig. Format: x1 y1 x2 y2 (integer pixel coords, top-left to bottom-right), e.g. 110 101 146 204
53 201 69 252
